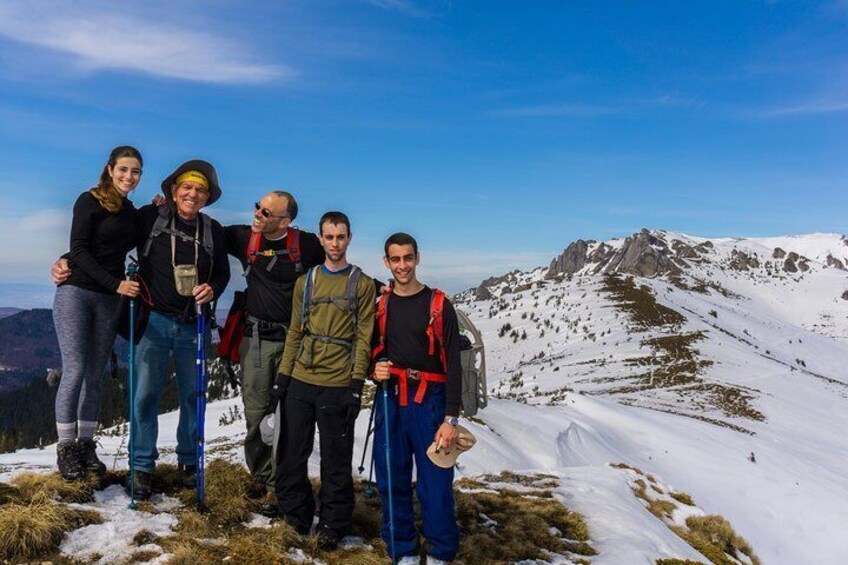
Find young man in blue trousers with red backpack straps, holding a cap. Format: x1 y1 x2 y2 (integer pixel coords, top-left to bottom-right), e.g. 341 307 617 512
373 233 462 564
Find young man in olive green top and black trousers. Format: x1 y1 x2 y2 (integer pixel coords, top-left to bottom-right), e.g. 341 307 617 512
275 212 375 550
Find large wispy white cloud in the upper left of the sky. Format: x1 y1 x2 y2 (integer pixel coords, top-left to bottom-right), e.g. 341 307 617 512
0 0 288 83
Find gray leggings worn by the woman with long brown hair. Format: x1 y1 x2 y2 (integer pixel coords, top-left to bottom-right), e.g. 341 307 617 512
53 285 118 441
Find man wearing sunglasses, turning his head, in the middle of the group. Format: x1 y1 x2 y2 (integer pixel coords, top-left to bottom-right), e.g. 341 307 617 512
225 190 324 502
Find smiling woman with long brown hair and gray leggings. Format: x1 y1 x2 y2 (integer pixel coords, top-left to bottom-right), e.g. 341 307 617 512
53 145 142 480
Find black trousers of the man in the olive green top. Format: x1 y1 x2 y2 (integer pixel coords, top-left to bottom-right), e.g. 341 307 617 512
276 378 354 536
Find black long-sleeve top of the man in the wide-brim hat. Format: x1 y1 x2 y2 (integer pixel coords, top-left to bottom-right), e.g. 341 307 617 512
138 204 230 314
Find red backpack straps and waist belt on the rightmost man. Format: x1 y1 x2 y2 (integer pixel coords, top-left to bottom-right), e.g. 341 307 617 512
371 286 448 406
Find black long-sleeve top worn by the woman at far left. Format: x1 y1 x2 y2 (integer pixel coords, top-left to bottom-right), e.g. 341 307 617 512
62 191 137 294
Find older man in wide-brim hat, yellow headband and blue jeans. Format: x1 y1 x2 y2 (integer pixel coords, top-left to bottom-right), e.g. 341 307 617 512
127 159 230 498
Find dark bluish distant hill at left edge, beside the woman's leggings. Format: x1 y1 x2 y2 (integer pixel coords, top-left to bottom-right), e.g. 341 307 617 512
0 309 62 371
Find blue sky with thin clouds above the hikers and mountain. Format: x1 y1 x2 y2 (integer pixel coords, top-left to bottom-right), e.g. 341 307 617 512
0 0 848 306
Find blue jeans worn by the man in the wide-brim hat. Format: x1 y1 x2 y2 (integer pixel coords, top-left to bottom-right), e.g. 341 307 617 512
130 311 211 473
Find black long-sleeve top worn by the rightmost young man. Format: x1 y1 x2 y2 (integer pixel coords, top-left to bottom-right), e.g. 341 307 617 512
384 286 462 416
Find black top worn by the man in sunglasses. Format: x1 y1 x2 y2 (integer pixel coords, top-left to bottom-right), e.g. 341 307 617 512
224 225 324 325
